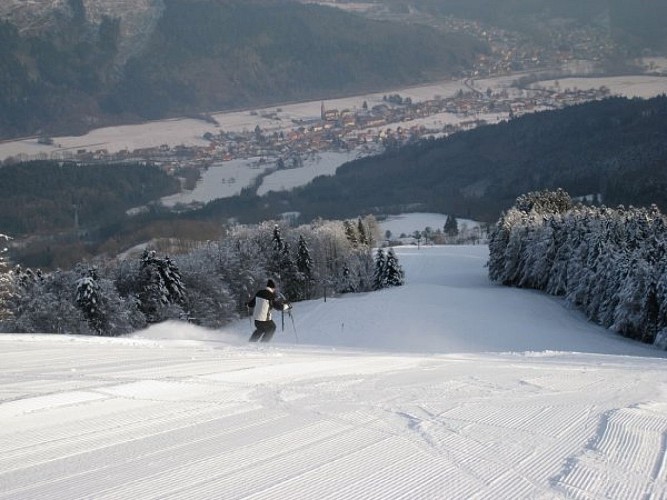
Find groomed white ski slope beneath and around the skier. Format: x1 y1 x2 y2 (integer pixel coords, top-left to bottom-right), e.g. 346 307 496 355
0 246 667 500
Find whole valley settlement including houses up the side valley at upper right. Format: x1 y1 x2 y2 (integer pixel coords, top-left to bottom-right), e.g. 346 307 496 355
4 9 636 193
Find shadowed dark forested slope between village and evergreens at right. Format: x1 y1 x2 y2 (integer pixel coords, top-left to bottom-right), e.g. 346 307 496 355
228 96 667 221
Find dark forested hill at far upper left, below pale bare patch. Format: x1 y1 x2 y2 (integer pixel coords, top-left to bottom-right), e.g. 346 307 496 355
0 18 118 138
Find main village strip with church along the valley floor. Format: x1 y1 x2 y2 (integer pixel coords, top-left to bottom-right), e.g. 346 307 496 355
57 83 610 178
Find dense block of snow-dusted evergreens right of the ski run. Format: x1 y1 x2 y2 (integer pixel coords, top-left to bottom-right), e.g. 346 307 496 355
489 190 667 348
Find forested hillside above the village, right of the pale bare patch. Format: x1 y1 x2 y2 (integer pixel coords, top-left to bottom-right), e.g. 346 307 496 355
100 0 483 118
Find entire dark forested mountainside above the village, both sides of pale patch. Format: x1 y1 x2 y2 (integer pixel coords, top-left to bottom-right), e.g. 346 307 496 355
0 0 486 138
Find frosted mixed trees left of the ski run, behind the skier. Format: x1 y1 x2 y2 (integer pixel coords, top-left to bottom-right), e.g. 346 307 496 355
0 217 404 336
